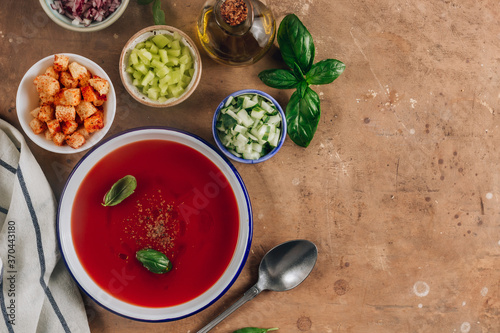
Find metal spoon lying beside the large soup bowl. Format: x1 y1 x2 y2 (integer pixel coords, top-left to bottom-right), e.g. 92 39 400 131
198 239 318 333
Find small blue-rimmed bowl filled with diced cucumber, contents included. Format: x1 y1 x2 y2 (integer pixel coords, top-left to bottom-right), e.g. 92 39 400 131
212 89 286 164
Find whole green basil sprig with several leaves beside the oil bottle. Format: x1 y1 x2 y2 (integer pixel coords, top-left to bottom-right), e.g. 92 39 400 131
259 14 345 147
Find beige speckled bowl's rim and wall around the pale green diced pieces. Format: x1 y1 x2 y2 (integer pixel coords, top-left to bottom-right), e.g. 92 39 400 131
120 25 202 108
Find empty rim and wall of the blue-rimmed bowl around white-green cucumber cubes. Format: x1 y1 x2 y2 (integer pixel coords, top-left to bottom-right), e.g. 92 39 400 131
212 89 287 164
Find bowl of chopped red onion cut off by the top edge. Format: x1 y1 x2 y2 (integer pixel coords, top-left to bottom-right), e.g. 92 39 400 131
40 0 129 32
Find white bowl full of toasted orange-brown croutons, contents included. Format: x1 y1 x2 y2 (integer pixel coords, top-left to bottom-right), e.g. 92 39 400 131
16 53 116 154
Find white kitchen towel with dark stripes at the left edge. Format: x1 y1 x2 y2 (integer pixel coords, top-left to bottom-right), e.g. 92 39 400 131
0 119 90 333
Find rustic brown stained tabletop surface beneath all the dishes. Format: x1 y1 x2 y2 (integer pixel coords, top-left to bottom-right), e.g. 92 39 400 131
0 0 500 333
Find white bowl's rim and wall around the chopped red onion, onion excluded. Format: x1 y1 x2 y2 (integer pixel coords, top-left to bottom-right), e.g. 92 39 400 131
40 0 129 32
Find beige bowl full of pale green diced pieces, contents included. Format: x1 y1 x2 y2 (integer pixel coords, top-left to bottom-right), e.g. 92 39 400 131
120 25 202 108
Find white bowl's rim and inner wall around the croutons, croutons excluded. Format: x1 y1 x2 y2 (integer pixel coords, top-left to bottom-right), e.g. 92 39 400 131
16 53 116 154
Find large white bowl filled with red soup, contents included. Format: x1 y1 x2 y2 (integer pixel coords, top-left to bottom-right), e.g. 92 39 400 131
57 127 253 321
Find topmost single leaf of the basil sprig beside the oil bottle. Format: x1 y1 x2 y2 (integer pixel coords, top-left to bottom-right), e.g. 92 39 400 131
277 14 316 73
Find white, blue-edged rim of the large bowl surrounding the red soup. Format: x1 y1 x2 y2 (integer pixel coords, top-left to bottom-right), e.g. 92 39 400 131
57 127 253 321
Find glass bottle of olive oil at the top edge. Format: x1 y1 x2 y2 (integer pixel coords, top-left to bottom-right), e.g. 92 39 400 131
197 0 276 66
